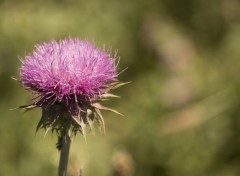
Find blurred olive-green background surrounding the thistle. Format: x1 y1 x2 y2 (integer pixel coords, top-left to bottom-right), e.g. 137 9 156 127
0 0 240 176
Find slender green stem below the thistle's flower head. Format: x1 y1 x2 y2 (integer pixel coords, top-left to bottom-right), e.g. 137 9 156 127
58 128 71 176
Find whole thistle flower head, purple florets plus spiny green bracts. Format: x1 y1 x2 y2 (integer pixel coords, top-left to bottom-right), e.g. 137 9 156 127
20 38 126 142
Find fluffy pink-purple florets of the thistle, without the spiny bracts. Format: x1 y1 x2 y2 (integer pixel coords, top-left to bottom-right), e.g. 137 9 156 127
20 38 117 106
